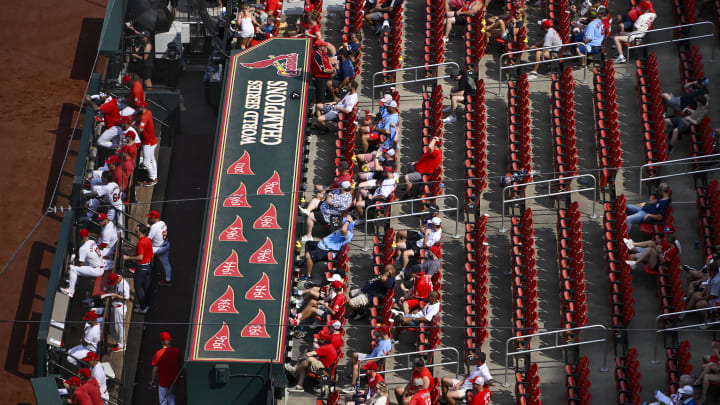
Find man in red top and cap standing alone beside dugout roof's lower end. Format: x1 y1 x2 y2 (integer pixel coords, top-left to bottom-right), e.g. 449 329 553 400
149 332 182 405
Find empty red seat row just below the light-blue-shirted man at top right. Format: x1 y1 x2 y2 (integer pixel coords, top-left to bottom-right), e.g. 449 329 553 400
593 60 622 188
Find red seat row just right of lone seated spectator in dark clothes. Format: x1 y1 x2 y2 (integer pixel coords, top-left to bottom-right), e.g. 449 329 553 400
465 79 487 211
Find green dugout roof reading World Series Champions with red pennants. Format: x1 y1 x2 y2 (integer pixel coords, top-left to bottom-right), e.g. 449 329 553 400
187 38 310 363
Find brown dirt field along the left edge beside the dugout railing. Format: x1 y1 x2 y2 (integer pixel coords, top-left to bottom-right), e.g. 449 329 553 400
0 0 105 404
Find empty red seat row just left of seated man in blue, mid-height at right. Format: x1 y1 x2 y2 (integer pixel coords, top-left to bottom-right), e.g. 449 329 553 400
603 194 635 328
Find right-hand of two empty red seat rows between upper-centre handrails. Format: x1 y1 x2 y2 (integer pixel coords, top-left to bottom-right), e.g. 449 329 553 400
550 66 578 186
